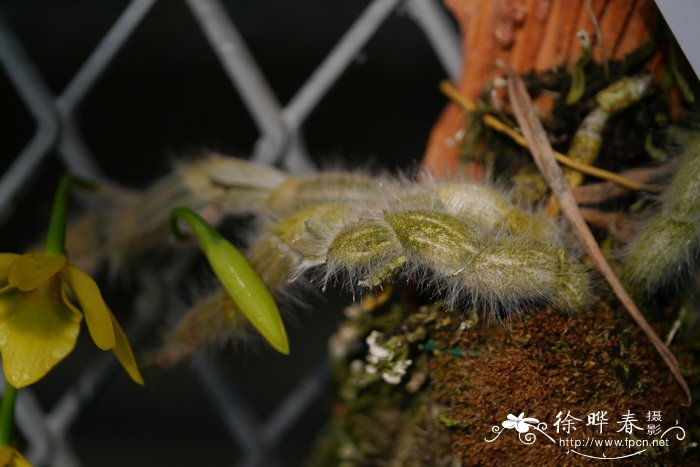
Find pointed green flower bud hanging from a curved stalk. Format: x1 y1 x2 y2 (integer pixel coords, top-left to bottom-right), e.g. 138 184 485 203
170 208 289 354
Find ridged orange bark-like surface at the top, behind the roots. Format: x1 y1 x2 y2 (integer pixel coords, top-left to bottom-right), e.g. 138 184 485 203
422 0 658 176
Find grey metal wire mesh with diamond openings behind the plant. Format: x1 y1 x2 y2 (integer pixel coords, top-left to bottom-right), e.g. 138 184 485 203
0 0 461 466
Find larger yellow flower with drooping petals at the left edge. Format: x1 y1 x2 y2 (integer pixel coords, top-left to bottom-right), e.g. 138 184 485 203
0 252 143 388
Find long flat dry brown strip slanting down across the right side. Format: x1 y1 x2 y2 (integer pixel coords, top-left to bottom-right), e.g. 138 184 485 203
506 68 692 406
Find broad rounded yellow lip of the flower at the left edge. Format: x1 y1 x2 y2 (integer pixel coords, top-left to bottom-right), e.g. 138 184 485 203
0 280 82 388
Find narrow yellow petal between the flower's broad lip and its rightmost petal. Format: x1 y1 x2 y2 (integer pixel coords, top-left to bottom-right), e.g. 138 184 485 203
63 263 116 350
